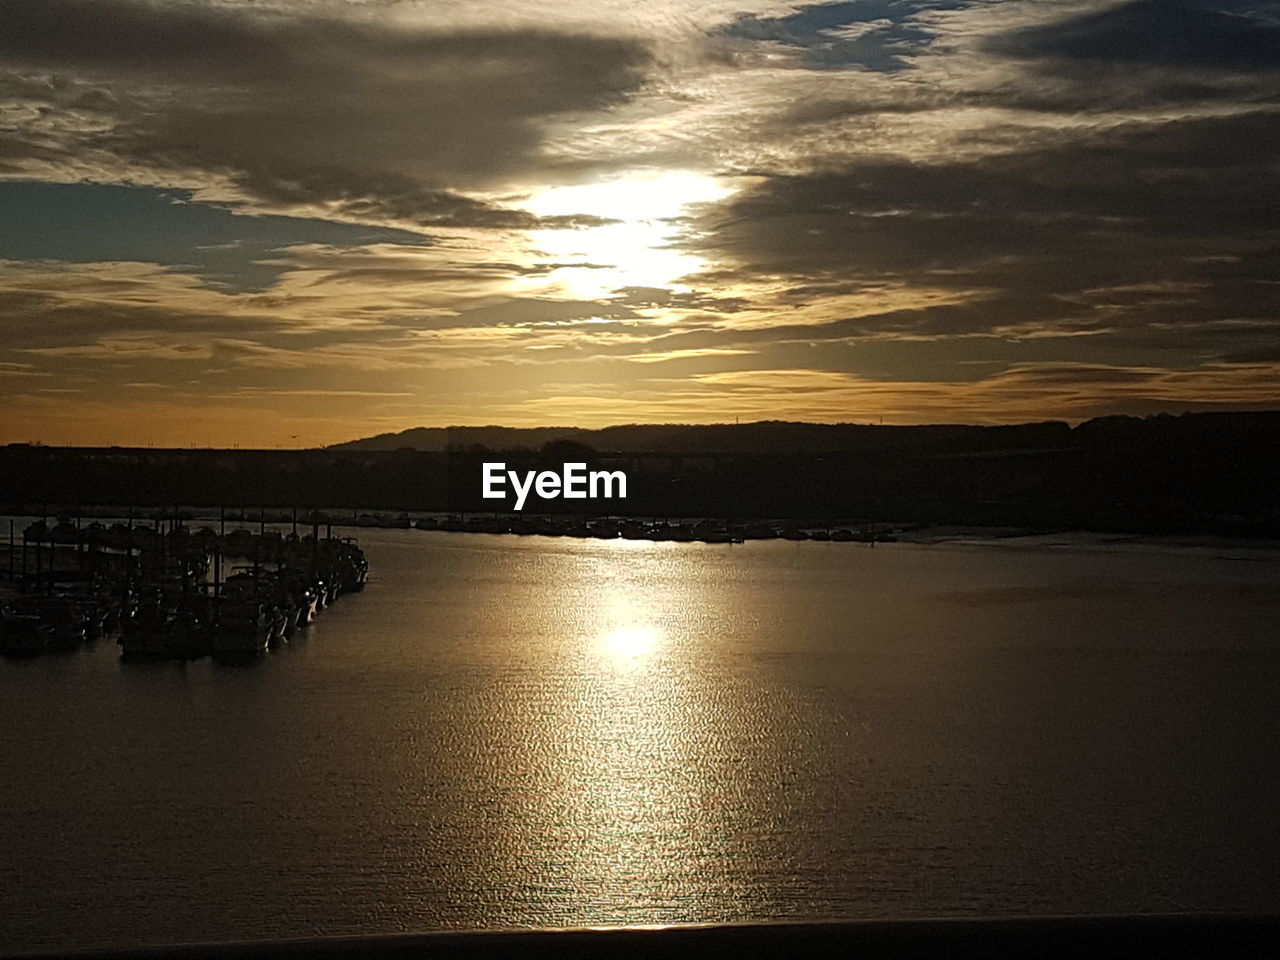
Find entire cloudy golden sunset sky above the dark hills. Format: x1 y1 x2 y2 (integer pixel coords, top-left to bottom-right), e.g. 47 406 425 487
0 0 1280 447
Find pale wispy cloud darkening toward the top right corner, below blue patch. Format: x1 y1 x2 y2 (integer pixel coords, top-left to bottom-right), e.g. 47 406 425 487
727 0 1280 161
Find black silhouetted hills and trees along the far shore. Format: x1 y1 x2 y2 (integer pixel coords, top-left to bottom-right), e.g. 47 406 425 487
0 412 1280 536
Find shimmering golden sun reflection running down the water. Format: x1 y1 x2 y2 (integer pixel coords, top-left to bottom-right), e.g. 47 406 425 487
471 541 754 924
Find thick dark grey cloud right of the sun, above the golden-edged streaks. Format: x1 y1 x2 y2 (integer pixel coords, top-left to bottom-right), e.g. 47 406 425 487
709 113 1280 273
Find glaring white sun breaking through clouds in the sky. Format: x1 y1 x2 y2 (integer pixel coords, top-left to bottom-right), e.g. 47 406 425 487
525 172 736 300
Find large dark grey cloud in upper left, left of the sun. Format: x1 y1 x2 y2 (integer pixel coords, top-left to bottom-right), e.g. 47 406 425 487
0 0 652 227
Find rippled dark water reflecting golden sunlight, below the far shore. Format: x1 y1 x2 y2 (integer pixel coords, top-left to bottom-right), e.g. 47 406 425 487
0 530 1280 952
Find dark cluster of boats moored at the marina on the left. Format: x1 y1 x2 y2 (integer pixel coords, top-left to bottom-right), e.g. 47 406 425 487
0 513 369 660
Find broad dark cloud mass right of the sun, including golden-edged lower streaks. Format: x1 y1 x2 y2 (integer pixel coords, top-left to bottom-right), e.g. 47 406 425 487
699 104 1280 356
